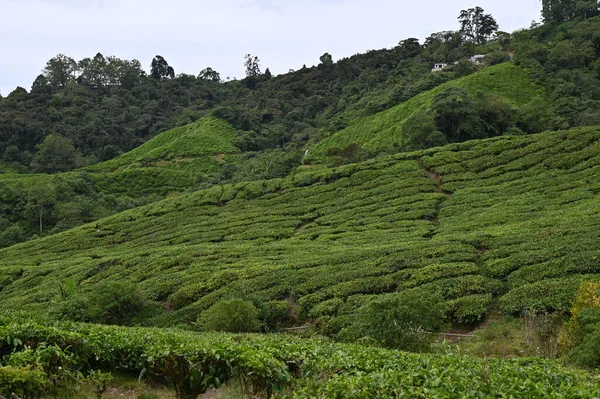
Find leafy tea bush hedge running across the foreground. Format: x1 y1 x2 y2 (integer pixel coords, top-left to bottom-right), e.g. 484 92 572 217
0 317 598 399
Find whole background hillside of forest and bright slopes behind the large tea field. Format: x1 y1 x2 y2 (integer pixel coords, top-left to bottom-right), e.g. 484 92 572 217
0 12 600 247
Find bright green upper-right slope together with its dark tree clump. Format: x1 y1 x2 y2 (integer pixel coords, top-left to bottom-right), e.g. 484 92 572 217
311 63 551 155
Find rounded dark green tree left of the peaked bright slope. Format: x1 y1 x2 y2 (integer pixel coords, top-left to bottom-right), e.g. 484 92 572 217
31 134 80 173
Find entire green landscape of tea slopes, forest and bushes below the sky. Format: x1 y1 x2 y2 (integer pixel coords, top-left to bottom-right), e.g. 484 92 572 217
0 1 600 399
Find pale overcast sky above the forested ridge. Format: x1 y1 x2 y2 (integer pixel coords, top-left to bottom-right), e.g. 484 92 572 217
0 0 541 96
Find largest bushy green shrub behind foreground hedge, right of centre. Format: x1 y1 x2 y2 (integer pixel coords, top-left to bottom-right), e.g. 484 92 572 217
340 291 444 351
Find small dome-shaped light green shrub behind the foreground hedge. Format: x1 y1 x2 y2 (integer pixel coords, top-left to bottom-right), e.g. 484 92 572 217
198 299 260 333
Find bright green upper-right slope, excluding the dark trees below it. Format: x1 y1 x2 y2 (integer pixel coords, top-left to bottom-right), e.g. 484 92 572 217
310 63 549 156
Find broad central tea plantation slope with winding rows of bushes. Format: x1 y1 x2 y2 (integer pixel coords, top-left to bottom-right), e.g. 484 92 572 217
0 128 600 334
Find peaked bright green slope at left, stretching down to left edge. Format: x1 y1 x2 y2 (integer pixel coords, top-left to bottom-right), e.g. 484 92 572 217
0 118 240 247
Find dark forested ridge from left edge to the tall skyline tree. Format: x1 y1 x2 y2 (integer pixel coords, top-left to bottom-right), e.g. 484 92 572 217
0 8 498 173
